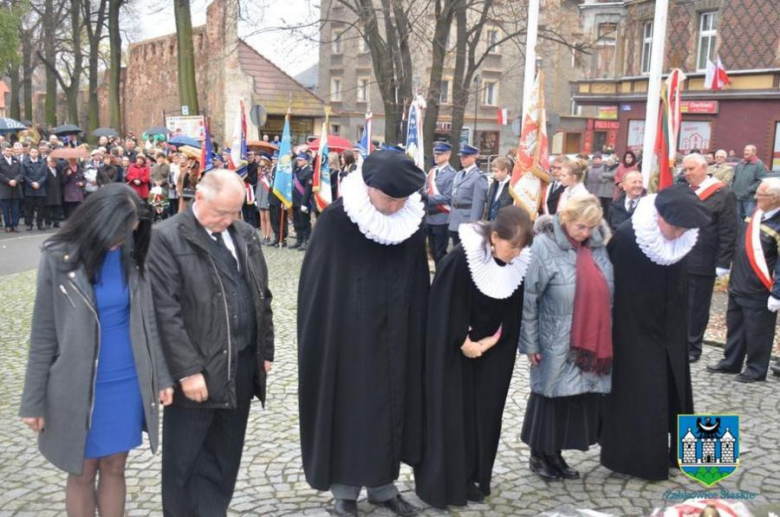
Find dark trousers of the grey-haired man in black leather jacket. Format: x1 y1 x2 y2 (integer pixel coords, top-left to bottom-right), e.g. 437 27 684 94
162 346 255 517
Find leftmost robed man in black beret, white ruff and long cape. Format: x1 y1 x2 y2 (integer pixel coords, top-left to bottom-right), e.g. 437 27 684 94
298 151 429 516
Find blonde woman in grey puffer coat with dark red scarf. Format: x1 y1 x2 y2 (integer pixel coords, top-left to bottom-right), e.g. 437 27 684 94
519 194 613 480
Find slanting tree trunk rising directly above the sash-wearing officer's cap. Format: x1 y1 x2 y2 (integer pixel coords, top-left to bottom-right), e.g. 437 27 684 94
423 0 454 157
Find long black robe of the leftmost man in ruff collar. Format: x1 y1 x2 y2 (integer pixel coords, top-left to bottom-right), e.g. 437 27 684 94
298 199 430 490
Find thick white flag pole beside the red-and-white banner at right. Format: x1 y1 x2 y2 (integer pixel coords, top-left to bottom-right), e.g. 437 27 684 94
642 0 669 188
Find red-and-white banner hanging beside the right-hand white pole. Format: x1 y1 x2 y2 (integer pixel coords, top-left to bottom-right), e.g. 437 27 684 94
655 68 686 192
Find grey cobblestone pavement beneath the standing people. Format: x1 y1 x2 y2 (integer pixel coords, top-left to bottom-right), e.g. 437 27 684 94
0 250 780 517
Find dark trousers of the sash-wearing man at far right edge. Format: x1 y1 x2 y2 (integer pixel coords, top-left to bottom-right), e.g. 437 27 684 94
718 294 777 380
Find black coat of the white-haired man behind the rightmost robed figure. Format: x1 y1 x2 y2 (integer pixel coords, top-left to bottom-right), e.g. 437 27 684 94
686 185 737 277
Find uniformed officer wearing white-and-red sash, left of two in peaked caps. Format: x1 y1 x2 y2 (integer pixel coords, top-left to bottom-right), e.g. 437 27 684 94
425 142 457 264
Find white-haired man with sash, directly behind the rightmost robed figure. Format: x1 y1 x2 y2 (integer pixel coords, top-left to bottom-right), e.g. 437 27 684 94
683 154 737 363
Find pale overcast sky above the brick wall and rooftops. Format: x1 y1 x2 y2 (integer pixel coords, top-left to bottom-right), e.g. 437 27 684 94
128 0 319 76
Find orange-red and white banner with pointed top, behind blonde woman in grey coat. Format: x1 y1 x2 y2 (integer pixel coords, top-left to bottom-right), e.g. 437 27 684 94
509 71 550 220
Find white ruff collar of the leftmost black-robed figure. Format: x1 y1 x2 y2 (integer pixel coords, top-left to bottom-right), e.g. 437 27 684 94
341 168 425 246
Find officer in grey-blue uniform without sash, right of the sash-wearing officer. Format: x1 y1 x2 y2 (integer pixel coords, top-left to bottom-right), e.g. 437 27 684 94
449 144 488 245
